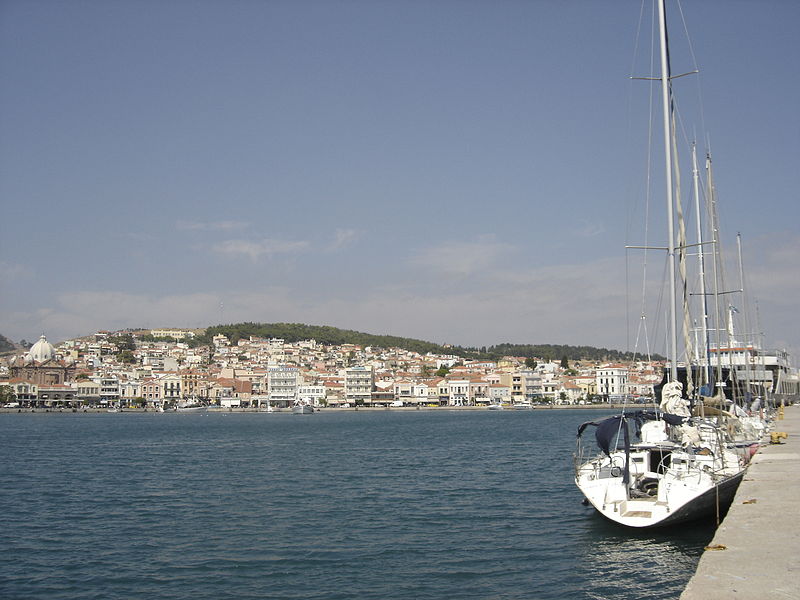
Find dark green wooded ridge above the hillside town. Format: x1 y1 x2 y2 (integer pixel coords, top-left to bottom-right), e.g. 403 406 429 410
189 322 644 361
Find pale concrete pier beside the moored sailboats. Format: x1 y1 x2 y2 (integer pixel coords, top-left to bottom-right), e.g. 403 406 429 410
681 406 800 600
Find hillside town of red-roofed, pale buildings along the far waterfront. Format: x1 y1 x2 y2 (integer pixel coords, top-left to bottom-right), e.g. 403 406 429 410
0 330 662 410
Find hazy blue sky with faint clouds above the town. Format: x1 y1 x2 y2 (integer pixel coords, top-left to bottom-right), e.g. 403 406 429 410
0 0 800 352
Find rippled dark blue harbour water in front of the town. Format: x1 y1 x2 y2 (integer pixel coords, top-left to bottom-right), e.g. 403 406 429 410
0 410 713 600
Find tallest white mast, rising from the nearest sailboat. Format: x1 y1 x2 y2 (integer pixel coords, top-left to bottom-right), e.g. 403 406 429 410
658 0 678 381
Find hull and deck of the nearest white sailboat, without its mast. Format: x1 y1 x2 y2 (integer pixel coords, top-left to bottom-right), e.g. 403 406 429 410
575 382 751 528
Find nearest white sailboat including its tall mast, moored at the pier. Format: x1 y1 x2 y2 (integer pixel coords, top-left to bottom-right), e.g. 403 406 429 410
575 0 750 528
